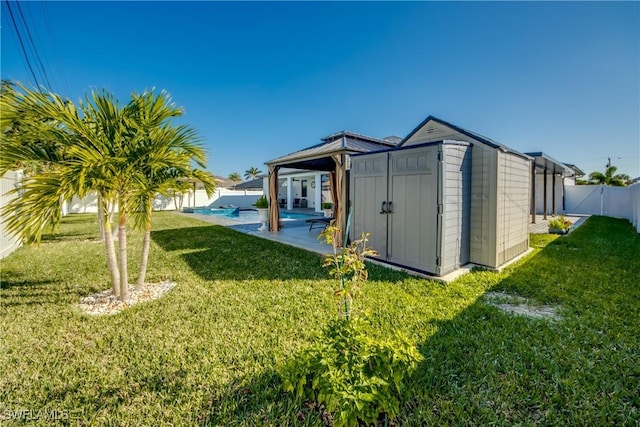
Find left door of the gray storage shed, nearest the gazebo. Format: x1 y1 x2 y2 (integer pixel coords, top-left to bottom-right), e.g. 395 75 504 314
350 153 389 260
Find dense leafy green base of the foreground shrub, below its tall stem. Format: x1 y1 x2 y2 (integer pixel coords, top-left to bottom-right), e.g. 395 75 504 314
280 319 423 426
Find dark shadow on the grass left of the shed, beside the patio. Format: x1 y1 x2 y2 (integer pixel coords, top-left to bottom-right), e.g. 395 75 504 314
151 225 327 280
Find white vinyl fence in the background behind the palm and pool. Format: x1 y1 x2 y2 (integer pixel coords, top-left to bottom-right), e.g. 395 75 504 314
63 188 264 215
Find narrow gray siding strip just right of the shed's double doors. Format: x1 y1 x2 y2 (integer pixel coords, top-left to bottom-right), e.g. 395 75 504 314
440 144 471 274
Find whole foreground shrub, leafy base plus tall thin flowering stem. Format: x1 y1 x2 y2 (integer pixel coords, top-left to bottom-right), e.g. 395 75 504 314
280 222 422 426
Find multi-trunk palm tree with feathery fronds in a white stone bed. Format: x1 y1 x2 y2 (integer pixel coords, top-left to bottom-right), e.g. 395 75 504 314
0 86 213 300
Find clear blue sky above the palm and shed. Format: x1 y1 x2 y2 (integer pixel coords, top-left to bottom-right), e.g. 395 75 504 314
0 2 640 177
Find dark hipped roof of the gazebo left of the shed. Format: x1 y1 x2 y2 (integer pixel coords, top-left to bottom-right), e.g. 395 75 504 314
266 131 396 171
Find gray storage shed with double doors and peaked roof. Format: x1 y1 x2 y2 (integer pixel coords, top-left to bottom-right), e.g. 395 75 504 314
350 116 532 276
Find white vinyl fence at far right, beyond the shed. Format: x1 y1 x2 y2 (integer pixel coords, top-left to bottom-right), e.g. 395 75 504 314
565 183 640 233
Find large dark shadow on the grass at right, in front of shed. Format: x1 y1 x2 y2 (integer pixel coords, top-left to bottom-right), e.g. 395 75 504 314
400 218 640 425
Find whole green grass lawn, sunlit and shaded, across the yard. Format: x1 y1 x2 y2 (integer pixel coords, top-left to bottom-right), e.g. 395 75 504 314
0 213 640 426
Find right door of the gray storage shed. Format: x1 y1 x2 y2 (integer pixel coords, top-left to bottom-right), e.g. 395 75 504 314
387 146 440 274
